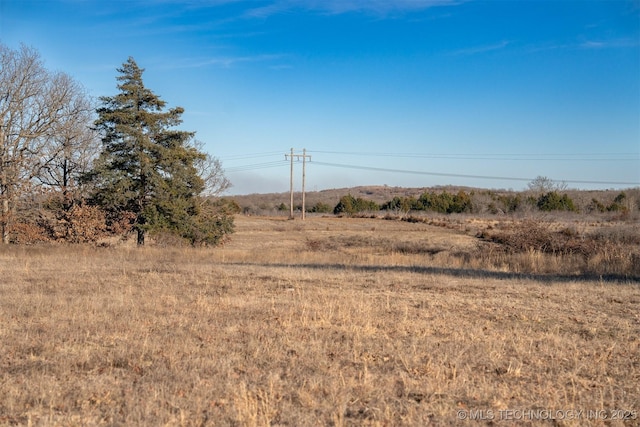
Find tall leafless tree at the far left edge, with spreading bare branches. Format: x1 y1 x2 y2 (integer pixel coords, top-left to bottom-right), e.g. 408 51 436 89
0 44 92 243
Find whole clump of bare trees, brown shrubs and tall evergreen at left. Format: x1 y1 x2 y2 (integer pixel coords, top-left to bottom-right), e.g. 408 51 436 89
0 44 237 245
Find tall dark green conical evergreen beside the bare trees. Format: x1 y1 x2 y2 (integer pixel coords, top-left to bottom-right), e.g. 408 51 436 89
86 58 230 245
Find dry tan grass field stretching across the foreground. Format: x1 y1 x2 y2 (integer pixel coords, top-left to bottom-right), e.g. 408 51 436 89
0 217 640 426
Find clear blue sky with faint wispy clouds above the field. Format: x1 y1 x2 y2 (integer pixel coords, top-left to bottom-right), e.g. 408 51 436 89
0 0 640 194
